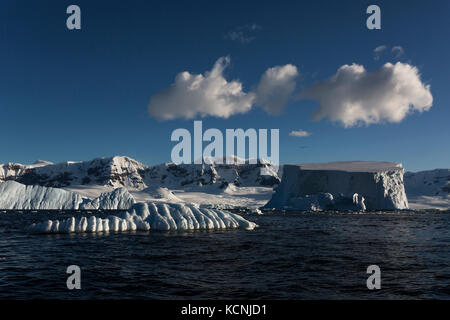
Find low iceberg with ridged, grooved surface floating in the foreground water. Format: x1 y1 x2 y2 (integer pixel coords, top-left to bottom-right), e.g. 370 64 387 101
29 202 257 233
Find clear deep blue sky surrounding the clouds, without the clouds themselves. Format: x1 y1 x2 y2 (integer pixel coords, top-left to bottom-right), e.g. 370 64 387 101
0 0 450 171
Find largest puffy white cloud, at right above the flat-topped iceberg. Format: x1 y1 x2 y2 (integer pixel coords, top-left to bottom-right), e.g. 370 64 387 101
301 62 433 127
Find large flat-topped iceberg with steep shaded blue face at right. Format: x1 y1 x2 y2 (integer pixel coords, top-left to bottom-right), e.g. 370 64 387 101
265 161 408 210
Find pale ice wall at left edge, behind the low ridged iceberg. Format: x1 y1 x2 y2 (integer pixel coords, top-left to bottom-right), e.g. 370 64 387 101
0 181 135 210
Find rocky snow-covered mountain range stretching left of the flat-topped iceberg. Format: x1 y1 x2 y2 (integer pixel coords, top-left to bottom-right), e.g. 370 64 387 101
0 156 280 190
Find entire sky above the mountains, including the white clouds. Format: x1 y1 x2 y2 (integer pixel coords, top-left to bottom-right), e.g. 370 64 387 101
0 0 450 171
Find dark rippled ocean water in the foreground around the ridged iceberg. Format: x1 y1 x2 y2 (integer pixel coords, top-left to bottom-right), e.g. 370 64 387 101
0 212 450 299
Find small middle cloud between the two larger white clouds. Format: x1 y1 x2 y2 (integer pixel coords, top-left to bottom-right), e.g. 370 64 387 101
256 64 298 114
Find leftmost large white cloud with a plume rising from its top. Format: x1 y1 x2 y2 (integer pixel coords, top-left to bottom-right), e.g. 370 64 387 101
148 57 255 120
